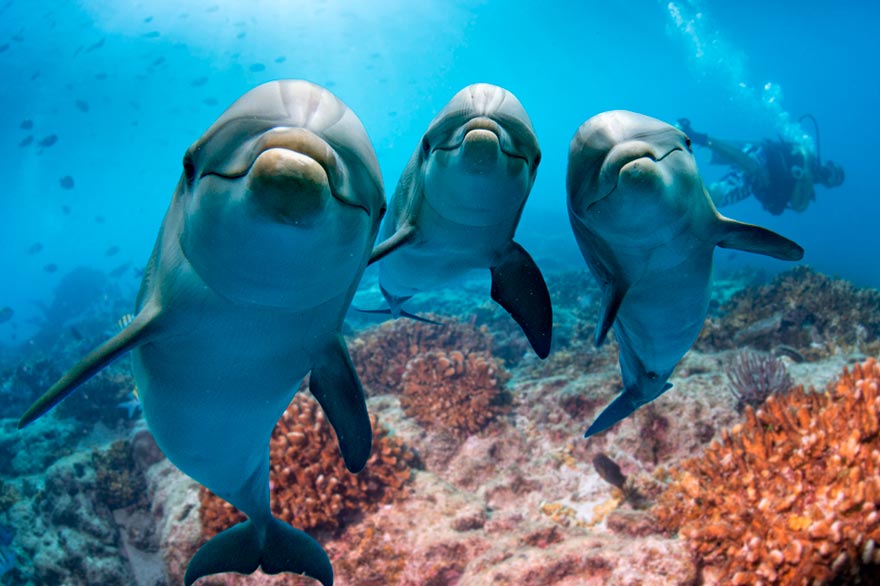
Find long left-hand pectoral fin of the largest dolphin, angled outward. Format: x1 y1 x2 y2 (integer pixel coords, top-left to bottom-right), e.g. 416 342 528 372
18 303 159 429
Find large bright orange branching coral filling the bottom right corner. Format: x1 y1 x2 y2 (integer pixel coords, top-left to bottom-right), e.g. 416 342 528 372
653 359 880 584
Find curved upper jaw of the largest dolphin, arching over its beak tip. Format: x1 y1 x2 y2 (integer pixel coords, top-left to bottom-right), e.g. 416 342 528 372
199 128 370 215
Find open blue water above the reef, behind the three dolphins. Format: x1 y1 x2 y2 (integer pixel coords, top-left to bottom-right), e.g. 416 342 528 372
0 0 880 341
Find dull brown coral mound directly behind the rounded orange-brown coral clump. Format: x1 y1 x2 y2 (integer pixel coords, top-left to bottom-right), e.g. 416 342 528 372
349 315 492 396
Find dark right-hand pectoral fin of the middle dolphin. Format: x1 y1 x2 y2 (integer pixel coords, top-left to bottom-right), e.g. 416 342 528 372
492 242 553 358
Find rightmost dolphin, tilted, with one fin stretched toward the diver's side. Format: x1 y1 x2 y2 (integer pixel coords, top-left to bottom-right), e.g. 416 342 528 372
567 110 804 437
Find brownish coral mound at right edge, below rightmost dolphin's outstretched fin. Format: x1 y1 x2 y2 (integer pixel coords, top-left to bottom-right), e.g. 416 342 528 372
696 266 880 360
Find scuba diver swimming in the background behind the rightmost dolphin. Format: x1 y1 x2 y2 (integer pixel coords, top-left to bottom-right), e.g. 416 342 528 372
678 114 844 216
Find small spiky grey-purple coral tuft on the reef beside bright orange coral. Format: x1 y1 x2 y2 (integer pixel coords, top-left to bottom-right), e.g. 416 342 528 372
727 352 794 413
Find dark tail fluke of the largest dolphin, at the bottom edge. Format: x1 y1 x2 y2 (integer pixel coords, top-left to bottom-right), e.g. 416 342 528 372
183 517 333 586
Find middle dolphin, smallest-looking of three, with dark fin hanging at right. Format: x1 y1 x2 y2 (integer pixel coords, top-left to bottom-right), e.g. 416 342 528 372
370 83 553 358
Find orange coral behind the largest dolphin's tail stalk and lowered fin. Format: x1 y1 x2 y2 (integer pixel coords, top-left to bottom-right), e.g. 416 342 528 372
200 393 412 538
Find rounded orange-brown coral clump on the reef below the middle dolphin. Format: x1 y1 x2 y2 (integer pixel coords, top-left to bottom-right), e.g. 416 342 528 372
400 350 508 436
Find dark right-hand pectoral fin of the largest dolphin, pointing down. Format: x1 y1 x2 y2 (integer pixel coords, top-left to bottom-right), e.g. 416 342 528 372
309 336 373 472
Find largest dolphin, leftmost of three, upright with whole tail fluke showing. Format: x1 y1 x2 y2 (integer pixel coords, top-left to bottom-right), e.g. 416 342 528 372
19 80 385 586
